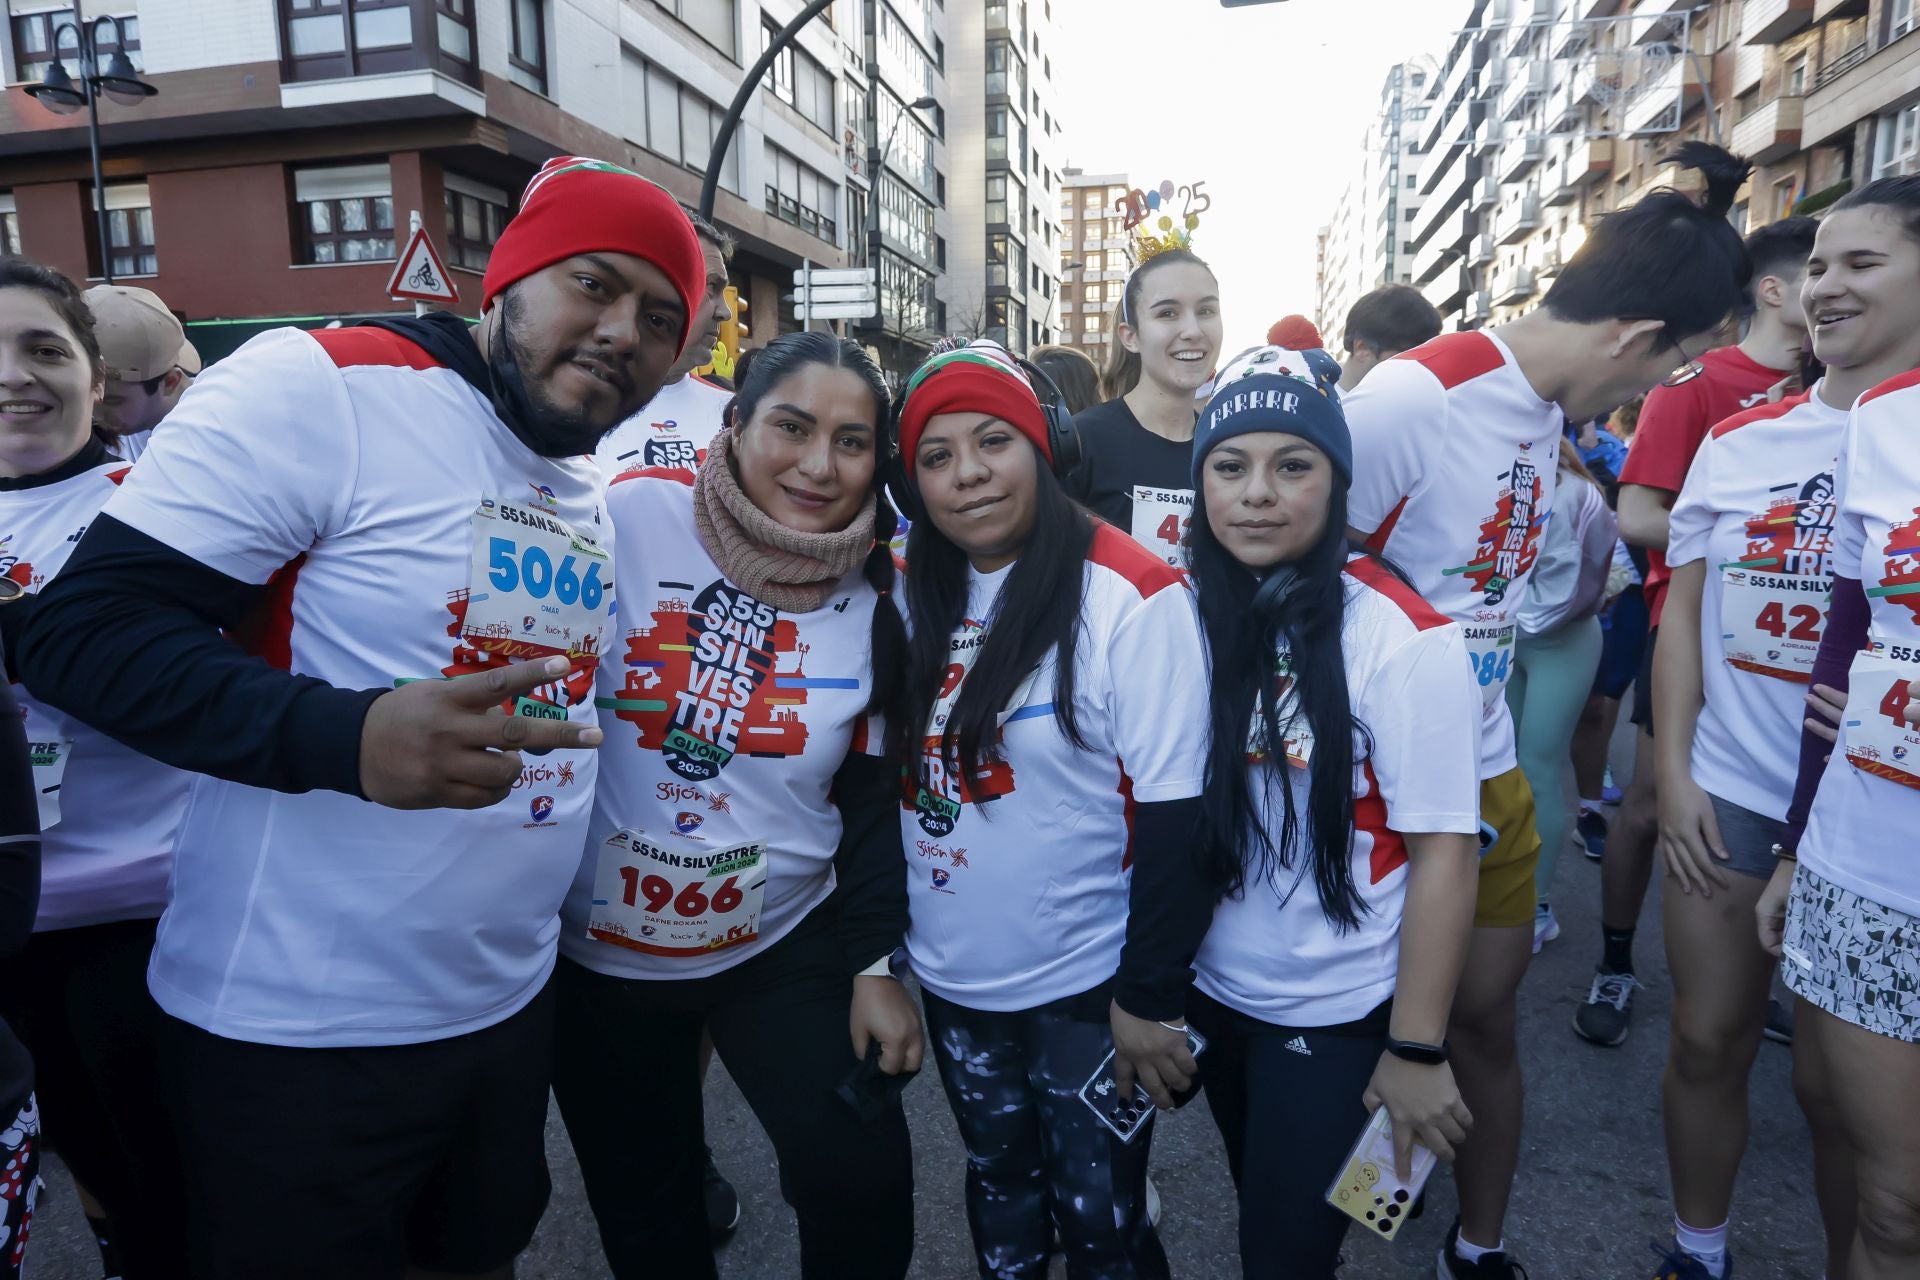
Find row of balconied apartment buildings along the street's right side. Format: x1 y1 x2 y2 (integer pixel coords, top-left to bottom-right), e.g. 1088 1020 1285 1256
1323 0 1920 328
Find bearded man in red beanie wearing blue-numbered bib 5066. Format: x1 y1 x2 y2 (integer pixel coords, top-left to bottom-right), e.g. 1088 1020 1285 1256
15 157 705 1280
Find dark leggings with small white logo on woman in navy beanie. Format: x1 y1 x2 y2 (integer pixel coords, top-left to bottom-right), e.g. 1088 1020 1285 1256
1188 990 1386 1280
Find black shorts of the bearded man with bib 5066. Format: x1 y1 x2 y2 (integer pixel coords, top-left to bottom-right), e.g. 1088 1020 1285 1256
163 983 553 1280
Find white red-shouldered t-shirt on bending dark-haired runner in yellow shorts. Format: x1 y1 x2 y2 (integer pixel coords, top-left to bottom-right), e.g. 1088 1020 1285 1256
1344 332 1565 781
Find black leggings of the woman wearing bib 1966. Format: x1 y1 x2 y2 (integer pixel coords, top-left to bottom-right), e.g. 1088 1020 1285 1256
553 908 914 1280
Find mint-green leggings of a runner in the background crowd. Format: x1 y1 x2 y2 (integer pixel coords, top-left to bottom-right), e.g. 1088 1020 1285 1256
1507 618 1601 902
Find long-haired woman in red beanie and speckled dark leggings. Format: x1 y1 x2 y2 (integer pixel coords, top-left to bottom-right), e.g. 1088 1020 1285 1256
891 342 1213 1280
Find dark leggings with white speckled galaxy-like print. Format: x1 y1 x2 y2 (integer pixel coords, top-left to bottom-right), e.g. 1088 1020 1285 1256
922 990 1169 1280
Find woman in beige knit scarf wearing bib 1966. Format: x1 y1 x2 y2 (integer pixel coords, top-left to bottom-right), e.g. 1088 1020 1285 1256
552 334 922 1280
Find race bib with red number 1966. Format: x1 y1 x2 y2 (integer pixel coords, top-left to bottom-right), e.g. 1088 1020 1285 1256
588 827 766 958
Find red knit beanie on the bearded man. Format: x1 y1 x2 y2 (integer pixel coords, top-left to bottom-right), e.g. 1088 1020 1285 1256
480 155 707 358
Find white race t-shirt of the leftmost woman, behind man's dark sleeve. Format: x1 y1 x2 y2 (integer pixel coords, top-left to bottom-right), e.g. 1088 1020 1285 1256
0 459 192 933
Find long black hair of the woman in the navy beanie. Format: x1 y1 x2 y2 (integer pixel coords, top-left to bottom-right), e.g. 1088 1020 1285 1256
1187 486 1373 933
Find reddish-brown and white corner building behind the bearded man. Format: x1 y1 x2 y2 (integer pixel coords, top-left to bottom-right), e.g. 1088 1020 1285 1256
0 0 867 355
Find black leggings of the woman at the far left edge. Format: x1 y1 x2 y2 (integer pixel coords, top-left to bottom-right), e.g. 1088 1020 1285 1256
0 919 188 1280
